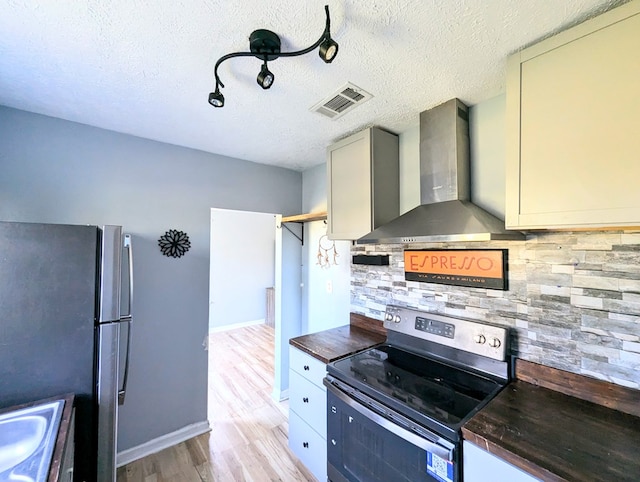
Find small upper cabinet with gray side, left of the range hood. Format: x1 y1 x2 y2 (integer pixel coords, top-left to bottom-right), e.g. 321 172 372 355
327 127 400 240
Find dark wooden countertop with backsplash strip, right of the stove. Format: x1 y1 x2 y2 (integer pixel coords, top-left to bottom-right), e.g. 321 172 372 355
462 359 640 482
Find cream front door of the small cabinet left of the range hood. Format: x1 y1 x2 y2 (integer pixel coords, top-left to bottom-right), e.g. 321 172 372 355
327 130 372 239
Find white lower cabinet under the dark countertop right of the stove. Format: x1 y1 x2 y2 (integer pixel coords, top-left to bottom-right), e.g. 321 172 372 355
462 440 540 482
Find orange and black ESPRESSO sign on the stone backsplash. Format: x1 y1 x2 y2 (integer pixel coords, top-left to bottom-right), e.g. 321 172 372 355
404 249 507 290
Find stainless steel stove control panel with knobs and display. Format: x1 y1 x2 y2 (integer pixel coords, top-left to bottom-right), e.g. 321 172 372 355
384 305 508 361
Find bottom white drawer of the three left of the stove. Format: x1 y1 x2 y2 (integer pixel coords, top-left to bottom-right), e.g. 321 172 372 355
289 412 327 482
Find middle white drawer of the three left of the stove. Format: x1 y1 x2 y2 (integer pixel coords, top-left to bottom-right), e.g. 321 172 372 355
289 372 327 437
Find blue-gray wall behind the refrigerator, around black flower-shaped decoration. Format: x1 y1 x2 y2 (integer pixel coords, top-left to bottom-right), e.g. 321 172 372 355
0 107 302 451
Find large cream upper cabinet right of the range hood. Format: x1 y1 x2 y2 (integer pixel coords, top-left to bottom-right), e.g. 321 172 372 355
506 1 640 229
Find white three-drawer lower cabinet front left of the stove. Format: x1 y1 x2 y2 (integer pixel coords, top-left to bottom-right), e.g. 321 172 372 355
289 347 327 482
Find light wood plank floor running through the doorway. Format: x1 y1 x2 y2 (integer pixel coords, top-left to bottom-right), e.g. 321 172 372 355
117 325 316 482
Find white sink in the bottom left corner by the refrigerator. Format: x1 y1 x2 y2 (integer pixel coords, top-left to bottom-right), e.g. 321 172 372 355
0 400 64 482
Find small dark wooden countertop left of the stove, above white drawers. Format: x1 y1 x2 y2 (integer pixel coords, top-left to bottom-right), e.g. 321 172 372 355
289 313 387 363
